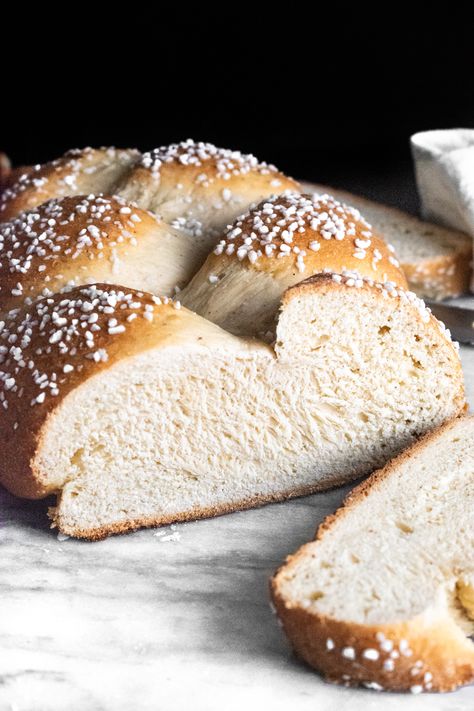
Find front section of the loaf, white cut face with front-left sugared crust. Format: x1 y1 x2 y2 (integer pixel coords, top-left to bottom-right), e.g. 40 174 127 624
0 276 465 539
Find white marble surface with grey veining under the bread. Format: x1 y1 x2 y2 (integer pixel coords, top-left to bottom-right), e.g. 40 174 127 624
0 348 474 711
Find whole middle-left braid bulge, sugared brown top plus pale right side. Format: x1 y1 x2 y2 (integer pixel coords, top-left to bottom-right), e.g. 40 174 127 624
0 195 201 312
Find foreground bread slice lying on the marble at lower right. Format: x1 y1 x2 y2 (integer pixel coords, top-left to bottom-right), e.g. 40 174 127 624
272 417 474 693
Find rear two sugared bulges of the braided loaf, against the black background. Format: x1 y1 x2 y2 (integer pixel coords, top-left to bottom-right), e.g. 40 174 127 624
0 140 298 253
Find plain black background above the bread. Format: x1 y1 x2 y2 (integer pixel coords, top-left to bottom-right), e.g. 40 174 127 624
1 11 474 209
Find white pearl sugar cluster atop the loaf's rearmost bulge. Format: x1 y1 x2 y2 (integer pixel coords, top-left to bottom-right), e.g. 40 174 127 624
140 138 277 184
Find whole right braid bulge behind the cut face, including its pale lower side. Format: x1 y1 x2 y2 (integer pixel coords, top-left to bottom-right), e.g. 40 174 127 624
180 191 407 338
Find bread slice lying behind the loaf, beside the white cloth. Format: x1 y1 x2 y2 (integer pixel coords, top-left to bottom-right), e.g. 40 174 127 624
303 183 472 301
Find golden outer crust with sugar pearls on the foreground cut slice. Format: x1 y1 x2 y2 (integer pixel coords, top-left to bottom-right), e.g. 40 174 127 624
272 596 474 693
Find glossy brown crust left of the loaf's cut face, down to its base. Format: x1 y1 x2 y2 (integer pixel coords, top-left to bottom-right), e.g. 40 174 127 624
0 284 184 498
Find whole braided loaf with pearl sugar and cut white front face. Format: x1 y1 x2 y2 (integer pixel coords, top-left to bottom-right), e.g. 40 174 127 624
0 142 465 538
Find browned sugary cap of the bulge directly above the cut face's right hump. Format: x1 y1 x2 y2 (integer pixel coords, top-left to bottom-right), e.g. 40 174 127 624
211 193 407 287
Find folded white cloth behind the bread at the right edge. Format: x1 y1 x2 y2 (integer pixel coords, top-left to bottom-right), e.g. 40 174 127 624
411 128 474 291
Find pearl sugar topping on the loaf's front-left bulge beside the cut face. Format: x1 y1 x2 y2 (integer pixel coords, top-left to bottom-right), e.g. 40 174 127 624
0 285 180 418
